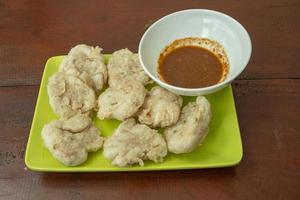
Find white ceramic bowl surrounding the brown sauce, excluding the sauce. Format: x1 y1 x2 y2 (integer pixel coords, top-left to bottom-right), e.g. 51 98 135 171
139 9 252 96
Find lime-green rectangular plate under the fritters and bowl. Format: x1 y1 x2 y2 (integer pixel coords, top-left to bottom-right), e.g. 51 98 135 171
25 55 243 172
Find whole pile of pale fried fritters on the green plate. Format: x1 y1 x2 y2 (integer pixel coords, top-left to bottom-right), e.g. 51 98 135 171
41 44 211 167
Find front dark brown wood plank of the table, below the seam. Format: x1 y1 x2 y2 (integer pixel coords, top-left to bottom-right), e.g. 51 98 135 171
0 80 300 200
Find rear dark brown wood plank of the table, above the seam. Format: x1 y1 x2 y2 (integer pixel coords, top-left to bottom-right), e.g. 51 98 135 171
0 0 300 86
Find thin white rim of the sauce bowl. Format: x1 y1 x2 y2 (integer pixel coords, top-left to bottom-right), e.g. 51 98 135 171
138 9 252 92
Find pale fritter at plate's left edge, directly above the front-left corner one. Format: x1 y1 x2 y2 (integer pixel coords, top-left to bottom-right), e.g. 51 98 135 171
47 72 96 119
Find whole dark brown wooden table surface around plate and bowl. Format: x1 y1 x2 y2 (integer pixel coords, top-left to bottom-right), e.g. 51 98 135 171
0 0 300 200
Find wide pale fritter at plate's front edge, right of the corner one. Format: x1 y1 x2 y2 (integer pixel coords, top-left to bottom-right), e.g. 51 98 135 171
103 118 167 167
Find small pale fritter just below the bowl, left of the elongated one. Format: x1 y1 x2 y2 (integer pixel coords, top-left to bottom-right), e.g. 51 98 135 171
138 86 182 127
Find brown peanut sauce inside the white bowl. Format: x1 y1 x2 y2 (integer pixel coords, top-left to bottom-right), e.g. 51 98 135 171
158 46 225 88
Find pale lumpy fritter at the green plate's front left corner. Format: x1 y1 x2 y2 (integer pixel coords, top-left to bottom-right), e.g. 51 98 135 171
41 115 104 166
